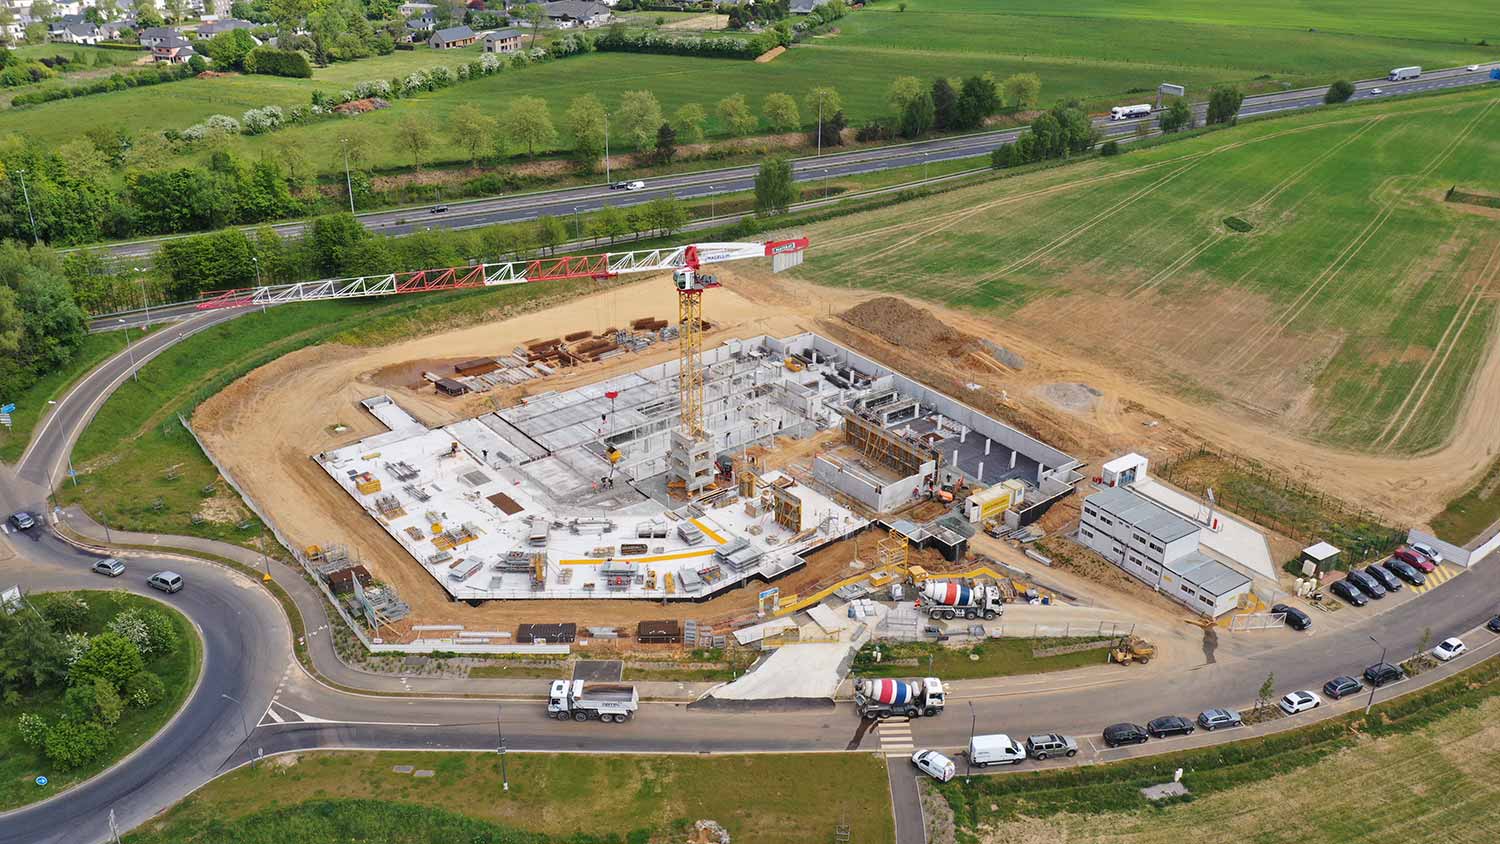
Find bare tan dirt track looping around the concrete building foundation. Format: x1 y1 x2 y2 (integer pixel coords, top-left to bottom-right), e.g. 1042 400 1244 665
194 270 1500 624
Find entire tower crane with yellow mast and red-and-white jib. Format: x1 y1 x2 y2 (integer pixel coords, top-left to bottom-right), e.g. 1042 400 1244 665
197 237 807 476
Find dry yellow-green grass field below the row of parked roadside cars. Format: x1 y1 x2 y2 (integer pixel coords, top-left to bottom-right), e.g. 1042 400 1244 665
947 659 1500 844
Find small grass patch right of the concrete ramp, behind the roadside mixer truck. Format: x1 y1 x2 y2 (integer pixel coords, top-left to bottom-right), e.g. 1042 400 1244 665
854 639 1109 681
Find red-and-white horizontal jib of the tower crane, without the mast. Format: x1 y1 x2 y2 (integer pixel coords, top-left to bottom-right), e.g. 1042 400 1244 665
198 237 807 310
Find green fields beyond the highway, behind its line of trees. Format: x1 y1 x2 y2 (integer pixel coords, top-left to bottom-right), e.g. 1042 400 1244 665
0 0 1500 179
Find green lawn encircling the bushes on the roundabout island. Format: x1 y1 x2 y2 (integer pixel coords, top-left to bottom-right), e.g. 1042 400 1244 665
0 591 203 811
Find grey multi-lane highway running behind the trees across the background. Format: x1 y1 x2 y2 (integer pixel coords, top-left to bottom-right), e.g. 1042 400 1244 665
90 63 1500 258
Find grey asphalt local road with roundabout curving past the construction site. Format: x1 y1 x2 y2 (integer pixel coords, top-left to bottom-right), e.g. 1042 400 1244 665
0 310 1500 844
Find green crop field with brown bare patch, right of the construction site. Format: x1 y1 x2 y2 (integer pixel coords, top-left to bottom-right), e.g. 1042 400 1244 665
798 90 1500 453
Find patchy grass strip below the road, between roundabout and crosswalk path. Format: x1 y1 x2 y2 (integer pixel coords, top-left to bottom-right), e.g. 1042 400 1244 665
126 753 896 844
